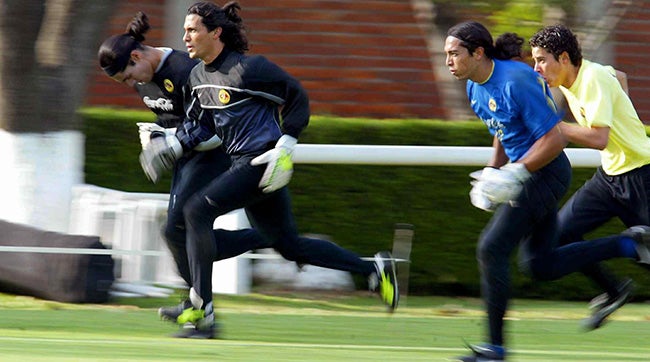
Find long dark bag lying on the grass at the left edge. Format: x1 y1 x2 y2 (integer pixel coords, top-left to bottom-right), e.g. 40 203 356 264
0 220 115 303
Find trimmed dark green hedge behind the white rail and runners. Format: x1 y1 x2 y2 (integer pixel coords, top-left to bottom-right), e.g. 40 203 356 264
81 109 650 299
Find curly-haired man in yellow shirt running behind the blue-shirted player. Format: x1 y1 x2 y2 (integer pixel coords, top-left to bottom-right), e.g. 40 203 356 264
530 25 650 330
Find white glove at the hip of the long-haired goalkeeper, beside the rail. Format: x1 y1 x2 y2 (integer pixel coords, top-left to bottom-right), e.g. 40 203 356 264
251 134 298 193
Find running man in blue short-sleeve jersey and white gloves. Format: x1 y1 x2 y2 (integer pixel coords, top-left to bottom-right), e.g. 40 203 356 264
445 22 650 362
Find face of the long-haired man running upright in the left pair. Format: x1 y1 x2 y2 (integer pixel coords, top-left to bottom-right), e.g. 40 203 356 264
183 14 221 63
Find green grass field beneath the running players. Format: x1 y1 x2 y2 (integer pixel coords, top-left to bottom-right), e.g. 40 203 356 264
0 293 650 362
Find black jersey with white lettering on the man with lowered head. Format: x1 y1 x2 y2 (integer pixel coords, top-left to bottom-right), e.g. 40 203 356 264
135 50 198 128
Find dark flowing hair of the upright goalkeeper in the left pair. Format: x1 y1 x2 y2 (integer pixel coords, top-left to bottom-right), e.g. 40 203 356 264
187 1 249 53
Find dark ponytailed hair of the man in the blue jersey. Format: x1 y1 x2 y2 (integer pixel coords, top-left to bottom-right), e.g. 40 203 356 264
447 21 524 59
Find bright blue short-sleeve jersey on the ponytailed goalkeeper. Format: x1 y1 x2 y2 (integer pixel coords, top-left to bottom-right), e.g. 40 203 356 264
467 59 561 162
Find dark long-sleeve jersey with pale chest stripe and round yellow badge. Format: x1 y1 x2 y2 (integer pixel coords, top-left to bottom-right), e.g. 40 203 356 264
176 48 309 155
